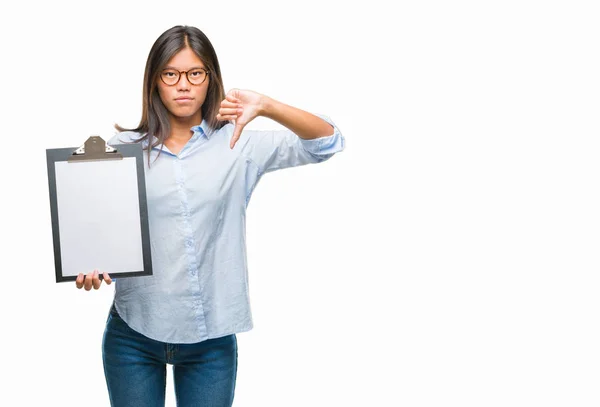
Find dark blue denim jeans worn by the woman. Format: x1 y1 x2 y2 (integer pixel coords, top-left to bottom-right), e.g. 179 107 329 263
102 305 237 407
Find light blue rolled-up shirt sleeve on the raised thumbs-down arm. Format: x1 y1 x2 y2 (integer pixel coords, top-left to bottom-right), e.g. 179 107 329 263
238 114 345 174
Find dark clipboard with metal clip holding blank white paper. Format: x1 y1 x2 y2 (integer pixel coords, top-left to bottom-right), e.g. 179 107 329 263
46 136 152 283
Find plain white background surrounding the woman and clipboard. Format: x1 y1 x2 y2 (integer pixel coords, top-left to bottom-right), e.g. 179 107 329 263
0 0 600 407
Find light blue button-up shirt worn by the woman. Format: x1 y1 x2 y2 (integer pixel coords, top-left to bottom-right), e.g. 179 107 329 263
108 115 345 343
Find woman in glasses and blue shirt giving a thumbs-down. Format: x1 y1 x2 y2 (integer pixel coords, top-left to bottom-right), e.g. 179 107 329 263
76 26 344 407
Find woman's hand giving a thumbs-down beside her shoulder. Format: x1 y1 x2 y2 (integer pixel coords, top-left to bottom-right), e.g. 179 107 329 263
217 89 264 148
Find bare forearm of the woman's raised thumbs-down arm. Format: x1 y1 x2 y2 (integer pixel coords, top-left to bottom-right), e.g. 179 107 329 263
260 95 333 140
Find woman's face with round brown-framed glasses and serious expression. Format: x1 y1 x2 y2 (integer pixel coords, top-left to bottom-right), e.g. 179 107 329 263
157 48 210 124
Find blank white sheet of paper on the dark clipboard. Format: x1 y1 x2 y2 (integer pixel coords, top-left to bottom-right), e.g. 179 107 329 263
55 157 144 276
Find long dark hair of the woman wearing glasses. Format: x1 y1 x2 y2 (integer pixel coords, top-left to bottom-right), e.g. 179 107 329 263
115 25 228 163
